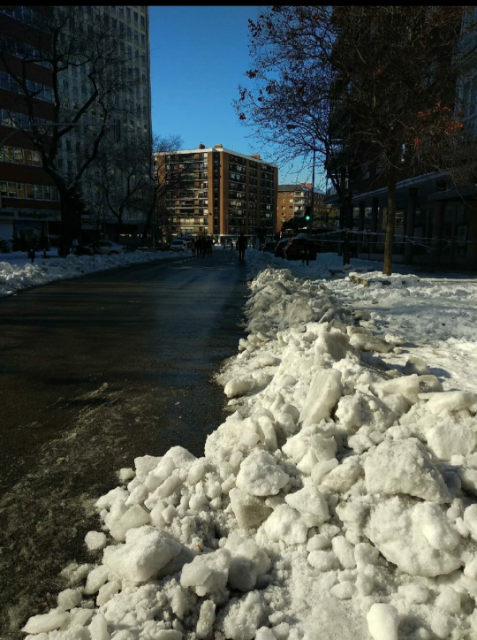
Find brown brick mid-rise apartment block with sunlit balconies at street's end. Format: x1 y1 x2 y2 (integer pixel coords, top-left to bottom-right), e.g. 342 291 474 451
155 144 278 243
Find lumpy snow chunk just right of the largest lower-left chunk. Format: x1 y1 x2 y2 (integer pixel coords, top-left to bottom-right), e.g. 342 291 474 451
181 549 231 596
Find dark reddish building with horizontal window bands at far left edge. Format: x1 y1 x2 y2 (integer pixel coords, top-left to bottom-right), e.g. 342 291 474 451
0 6 60 242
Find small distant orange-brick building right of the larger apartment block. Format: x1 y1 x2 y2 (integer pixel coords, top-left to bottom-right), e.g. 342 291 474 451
275 182 329 233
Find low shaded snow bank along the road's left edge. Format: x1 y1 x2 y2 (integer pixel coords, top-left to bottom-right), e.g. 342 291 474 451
0 251 186 297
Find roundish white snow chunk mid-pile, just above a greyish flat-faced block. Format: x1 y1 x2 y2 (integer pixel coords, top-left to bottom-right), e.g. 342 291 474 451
237 451 290 496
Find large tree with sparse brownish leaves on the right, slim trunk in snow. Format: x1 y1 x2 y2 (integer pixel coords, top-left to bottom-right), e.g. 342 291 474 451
238 6 474 273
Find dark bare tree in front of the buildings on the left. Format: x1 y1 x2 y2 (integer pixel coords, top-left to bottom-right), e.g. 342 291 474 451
0 6 134 255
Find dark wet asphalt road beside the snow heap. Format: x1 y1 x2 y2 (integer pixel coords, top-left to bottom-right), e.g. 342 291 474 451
0 251 247 640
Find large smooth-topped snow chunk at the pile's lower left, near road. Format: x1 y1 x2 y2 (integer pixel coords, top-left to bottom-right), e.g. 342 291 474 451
104 526 181 582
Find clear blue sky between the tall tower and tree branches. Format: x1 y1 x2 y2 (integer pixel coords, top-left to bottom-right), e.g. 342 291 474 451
149 6 320 186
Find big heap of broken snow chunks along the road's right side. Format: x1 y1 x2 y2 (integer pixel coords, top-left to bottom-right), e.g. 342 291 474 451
24 262 477 640
